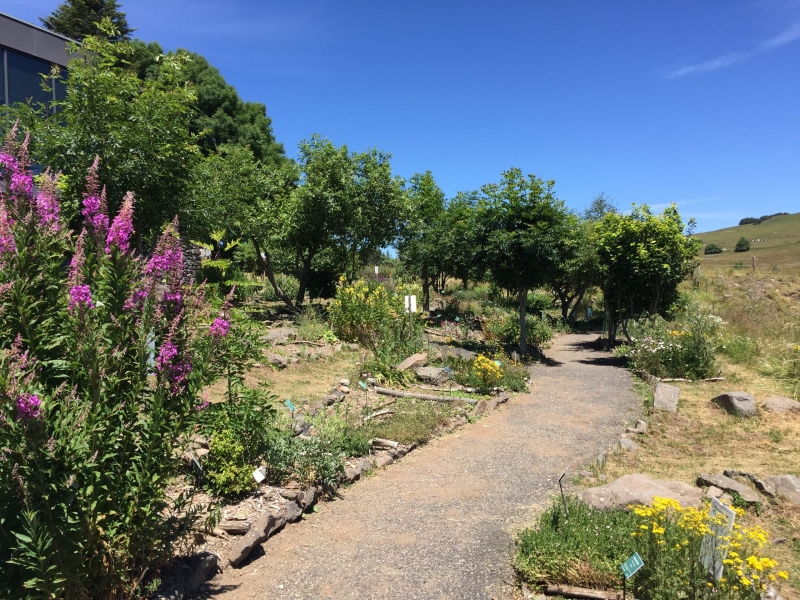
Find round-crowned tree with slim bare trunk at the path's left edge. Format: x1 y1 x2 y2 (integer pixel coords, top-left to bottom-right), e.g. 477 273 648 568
477 168 568 353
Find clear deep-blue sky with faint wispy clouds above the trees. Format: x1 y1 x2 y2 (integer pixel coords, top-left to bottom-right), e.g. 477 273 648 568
6 0 800 231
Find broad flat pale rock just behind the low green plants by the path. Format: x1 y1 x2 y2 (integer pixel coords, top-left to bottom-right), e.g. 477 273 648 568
581 473 702 508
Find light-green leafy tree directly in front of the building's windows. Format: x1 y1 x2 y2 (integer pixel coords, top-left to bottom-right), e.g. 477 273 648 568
9 19 198 249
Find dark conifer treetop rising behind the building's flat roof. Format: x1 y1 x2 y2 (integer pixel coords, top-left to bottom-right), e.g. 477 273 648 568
39 0 136 42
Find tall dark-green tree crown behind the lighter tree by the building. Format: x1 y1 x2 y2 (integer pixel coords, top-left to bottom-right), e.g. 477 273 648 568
130 40 284 164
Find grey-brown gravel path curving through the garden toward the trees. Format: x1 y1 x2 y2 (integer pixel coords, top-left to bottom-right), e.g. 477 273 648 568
205 335 641 600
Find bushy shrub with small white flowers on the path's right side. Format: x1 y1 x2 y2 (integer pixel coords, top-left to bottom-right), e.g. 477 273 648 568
616 305 724 379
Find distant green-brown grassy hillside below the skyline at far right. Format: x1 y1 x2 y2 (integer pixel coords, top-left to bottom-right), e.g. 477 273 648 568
697 213 800 268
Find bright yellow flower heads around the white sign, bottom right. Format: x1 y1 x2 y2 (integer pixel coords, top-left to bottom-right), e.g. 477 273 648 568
631 497 788 597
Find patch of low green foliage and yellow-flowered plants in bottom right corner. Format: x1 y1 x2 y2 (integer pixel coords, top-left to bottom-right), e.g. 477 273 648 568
514 497 788 600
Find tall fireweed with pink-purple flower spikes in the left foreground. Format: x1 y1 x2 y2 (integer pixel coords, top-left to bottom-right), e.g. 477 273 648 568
0 128 230 598
